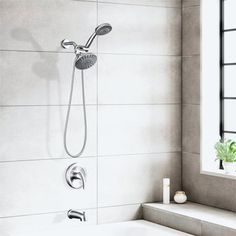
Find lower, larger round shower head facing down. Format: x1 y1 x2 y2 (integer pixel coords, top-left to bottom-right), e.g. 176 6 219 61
75 53 97 70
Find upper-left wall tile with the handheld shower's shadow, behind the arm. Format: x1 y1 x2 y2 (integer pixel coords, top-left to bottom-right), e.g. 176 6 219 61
0 0 97 51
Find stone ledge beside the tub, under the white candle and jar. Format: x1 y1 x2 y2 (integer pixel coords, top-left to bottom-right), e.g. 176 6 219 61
143 202 236 236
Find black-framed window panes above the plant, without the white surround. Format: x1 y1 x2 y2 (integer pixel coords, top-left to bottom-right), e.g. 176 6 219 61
220 0 236 146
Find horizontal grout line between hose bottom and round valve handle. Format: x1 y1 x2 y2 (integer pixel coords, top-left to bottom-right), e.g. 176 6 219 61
0 150 181 164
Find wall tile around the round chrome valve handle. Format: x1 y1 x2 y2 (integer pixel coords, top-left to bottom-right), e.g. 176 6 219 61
0 158 96 217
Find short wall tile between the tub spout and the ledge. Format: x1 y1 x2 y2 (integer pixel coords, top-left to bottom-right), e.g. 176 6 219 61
98 204 142 224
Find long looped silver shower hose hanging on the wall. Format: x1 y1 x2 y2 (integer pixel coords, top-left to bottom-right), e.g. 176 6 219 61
64 58 87 158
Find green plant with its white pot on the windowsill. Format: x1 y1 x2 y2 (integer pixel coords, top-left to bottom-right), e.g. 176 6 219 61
215 139 236 174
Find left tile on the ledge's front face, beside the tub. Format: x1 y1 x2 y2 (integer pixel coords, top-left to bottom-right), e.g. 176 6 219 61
143 207 201 236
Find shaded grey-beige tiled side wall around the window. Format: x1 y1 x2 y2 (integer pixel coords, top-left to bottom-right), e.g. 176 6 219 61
182 0 236 211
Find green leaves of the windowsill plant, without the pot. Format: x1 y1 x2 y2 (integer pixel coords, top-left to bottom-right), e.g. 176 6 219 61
215 139 236 162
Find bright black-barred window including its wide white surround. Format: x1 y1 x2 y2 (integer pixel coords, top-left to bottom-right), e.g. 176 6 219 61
201 0 236 178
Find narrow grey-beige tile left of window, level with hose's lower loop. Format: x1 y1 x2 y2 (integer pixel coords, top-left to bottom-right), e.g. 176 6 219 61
182 105 200 153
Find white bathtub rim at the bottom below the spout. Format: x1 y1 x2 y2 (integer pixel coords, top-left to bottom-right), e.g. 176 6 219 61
17 220 193 236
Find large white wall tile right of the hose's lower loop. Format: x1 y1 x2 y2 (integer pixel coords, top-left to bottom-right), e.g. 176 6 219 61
98 105 181 155
